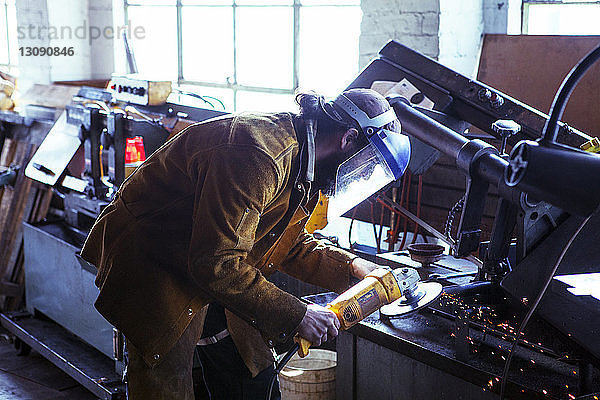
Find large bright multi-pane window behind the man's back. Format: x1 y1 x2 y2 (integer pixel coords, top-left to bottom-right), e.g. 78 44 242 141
125 0 362 111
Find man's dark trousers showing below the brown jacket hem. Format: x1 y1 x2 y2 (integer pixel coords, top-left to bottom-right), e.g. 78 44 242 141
127 308 281 400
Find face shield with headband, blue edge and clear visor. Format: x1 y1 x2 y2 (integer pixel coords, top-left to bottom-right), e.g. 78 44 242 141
323 94 410 218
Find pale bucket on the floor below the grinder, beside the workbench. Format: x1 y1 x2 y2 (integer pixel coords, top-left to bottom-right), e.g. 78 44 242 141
279 349 337 400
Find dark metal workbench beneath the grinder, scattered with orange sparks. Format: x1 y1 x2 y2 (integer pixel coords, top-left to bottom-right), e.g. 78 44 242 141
305 287 599 400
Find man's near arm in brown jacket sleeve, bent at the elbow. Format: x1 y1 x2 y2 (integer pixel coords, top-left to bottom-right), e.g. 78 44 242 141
188 145 306 346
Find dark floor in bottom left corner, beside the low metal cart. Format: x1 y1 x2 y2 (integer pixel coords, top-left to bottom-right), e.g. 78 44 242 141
0 328 96 400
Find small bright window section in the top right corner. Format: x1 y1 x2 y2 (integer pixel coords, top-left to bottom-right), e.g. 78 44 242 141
523 0 600 35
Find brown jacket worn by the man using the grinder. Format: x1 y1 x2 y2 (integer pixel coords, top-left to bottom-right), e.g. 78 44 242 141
81 113 354 375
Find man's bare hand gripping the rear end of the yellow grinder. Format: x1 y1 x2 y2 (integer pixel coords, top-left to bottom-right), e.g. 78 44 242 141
298 304 340 346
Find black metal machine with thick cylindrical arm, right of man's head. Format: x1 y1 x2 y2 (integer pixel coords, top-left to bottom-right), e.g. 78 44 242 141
350 41 600 366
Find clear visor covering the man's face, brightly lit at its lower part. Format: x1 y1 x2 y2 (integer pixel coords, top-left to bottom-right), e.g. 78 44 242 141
327 144 394 218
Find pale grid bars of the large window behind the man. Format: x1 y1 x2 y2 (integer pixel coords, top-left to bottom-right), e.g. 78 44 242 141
123 0 360 110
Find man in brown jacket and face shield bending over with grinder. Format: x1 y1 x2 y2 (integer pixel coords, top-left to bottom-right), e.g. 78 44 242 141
81 89 408 400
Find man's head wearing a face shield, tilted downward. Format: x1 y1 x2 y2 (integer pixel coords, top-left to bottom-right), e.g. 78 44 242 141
296 89 410 219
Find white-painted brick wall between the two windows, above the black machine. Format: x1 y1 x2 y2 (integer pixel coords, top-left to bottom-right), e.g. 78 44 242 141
359 0 521 76
